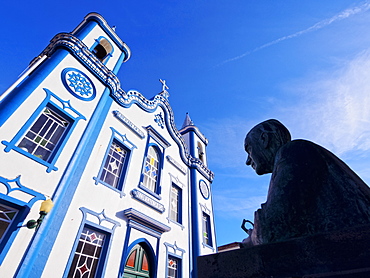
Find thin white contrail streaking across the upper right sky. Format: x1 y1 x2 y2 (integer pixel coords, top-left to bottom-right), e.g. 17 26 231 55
219 1 370 66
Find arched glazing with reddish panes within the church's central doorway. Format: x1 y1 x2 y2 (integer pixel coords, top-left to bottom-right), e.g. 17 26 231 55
123 244 150 278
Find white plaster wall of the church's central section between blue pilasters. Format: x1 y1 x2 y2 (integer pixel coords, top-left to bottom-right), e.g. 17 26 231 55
43 99 194 277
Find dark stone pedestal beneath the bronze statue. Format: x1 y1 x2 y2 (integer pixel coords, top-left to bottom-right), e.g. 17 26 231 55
198 225 370 278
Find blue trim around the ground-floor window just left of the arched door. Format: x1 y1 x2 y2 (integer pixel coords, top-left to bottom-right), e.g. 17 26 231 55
63 207 121 278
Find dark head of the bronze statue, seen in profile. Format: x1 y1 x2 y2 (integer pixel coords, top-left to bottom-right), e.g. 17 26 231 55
244 119 291 175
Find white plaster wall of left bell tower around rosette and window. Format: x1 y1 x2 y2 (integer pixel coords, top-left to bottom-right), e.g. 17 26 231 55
0 52 109 277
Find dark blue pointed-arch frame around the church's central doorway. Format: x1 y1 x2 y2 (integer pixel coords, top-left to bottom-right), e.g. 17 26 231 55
119 238 158 278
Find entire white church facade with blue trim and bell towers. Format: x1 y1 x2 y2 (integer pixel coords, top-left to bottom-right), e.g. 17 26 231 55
0 13 217 278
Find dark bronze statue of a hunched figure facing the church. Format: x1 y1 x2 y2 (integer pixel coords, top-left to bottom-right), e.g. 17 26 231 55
242 120 370 247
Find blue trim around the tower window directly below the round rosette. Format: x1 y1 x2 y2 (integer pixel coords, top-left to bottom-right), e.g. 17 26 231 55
1 88 86 173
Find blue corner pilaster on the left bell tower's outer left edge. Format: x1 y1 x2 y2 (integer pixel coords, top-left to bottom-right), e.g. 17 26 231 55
0 49 69 126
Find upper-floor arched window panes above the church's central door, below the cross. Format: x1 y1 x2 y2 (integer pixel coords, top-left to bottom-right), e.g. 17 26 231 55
143 146 159 192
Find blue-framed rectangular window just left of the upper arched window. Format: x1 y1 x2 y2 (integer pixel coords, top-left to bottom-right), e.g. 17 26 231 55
94 127 136 197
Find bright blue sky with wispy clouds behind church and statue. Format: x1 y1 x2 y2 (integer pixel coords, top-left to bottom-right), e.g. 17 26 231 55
0 0 370 245
